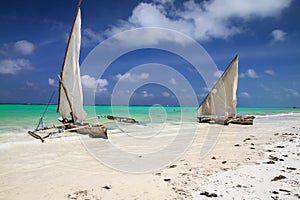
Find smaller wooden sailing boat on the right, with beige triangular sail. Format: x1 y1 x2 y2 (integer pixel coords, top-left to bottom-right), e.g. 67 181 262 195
198 56 254 125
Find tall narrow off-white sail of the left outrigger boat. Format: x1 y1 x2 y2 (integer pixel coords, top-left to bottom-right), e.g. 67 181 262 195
58 6 86 123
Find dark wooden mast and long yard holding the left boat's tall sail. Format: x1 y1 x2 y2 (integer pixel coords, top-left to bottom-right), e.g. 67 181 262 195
57 0 83 117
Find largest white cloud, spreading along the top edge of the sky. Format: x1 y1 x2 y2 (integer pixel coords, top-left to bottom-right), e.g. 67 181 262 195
105 0 292 41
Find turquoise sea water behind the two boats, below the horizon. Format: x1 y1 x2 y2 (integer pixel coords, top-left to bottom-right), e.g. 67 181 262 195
0 104 300 144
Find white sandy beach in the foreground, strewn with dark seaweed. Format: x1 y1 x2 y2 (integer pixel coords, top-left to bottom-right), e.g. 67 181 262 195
0 114 300 200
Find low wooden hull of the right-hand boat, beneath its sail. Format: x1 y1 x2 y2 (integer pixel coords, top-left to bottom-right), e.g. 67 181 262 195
198 116 255 125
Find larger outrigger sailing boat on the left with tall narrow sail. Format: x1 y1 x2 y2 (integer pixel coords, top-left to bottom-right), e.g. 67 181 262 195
28 0 137 142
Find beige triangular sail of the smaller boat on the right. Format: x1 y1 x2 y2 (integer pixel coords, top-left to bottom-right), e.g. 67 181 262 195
198 56 238 117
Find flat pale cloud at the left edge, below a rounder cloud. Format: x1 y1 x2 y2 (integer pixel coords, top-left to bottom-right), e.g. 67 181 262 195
0 58 33 74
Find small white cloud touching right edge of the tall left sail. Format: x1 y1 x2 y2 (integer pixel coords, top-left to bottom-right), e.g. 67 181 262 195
81 75 108 92
